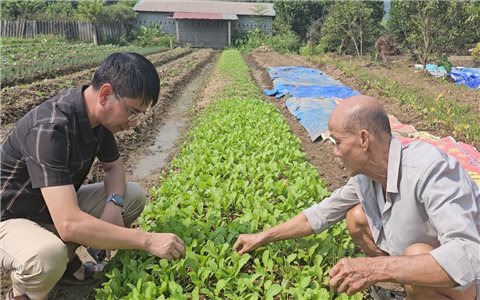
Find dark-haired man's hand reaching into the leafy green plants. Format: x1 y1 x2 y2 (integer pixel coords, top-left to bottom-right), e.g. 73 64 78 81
145 233 185 260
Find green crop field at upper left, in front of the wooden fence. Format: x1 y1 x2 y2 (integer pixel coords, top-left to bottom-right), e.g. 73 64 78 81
0 36 162 86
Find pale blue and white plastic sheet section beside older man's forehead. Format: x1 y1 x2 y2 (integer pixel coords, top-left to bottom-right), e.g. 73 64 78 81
285 97 341 141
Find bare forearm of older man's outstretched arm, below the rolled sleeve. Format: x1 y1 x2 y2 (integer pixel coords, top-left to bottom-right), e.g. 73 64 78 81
262 213 313 244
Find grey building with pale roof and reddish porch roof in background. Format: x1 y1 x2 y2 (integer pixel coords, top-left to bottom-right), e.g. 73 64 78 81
133 0 275 48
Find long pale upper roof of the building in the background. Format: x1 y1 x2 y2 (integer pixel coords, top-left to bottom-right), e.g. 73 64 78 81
133 0 275 17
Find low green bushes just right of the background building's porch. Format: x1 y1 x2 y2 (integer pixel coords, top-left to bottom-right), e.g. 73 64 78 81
234 28 302 53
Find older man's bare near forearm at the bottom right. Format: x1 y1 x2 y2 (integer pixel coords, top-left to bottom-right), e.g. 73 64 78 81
368 253 457 287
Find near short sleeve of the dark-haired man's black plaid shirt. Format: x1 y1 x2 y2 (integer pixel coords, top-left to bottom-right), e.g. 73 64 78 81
22 124 72 188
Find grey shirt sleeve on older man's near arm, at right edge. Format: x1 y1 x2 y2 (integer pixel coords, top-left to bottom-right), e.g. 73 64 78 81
418 157 480 286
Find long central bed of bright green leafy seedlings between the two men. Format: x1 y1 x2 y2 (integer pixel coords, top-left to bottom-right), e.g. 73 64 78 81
96 50 361 299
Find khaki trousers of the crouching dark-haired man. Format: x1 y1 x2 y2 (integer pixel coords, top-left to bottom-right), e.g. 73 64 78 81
0 182 146 299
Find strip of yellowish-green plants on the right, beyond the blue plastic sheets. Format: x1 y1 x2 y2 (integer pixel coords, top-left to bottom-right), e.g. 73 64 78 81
309 56 480 145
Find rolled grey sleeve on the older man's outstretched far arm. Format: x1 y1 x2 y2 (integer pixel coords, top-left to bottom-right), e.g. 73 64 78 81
303 177 360 233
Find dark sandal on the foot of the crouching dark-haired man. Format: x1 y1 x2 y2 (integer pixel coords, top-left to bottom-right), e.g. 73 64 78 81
59 254 105 285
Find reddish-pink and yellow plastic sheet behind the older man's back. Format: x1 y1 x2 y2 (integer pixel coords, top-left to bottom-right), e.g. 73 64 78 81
399 136 480 186
